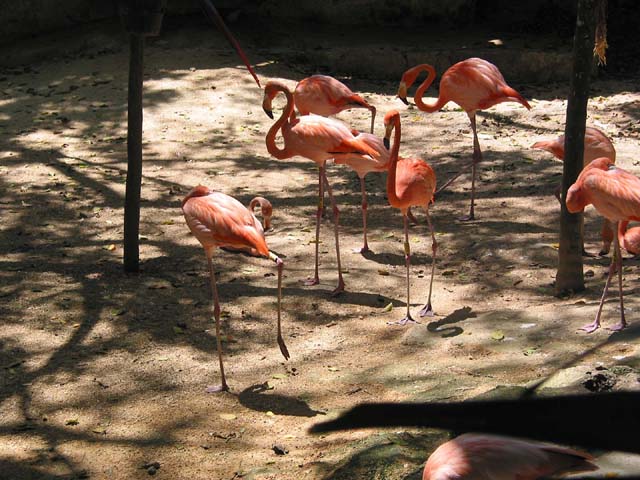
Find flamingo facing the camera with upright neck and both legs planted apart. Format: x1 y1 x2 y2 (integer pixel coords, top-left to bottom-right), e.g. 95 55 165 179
384 110 438 325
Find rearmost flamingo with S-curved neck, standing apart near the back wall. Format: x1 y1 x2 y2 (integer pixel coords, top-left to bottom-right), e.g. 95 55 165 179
398 58 531 220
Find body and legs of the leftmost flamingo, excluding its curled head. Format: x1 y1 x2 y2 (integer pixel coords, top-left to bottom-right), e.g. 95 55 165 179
182 185 289 393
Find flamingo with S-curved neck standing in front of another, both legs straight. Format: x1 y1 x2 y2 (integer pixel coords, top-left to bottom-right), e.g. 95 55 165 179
262 80 378 295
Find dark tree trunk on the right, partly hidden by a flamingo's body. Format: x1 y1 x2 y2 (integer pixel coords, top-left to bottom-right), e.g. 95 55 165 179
556 0 596 294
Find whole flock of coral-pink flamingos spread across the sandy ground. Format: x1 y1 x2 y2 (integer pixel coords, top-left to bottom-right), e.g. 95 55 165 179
182 51 640 480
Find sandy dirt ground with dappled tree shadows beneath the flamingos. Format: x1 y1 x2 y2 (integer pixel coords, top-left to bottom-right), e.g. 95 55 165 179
0 20 640 480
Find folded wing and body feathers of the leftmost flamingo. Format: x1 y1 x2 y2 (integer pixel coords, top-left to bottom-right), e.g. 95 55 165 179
182 191 269 256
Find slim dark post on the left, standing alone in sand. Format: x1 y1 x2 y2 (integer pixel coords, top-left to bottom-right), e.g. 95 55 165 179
124 33 144 272
